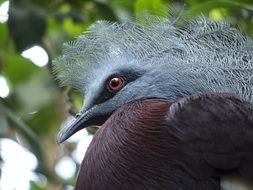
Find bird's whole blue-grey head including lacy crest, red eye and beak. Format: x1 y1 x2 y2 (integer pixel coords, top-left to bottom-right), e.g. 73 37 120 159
53 17 253 142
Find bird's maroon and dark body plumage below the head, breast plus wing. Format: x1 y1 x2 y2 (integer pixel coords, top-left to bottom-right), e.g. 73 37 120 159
76 94 253 190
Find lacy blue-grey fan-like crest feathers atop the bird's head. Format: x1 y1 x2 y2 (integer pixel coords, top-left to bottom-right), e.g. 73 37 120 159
53 12 253 101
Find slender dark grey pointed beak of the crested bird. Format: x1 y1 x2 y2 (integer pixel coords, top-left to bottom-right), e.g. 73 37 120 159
56 107 109 144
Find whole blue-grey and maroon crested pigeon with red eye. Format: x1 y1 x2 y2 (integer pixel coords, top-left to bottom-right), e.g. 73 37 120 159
53 12 253 190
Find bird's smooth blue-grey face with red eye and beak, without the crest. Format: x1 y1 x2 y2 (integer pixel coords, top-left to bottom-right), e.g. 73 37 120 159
57 59 165 143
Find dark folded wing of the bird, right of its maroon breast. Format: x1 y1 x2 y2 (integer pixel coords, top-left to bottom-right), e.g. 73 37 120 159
168 94 253 180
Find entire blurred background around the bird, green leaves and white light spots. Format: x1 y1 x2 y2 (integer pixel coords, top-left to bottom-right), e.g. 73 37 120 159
0 0 253 190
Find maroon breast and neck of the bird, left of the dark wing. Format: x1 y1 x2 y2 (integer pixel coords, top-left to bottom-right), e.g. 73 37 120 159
76 100 218 190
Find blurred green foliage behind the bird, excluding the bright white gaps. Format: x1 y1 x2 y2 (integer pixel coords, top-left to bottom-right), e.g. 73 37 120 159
0 0 253 189
